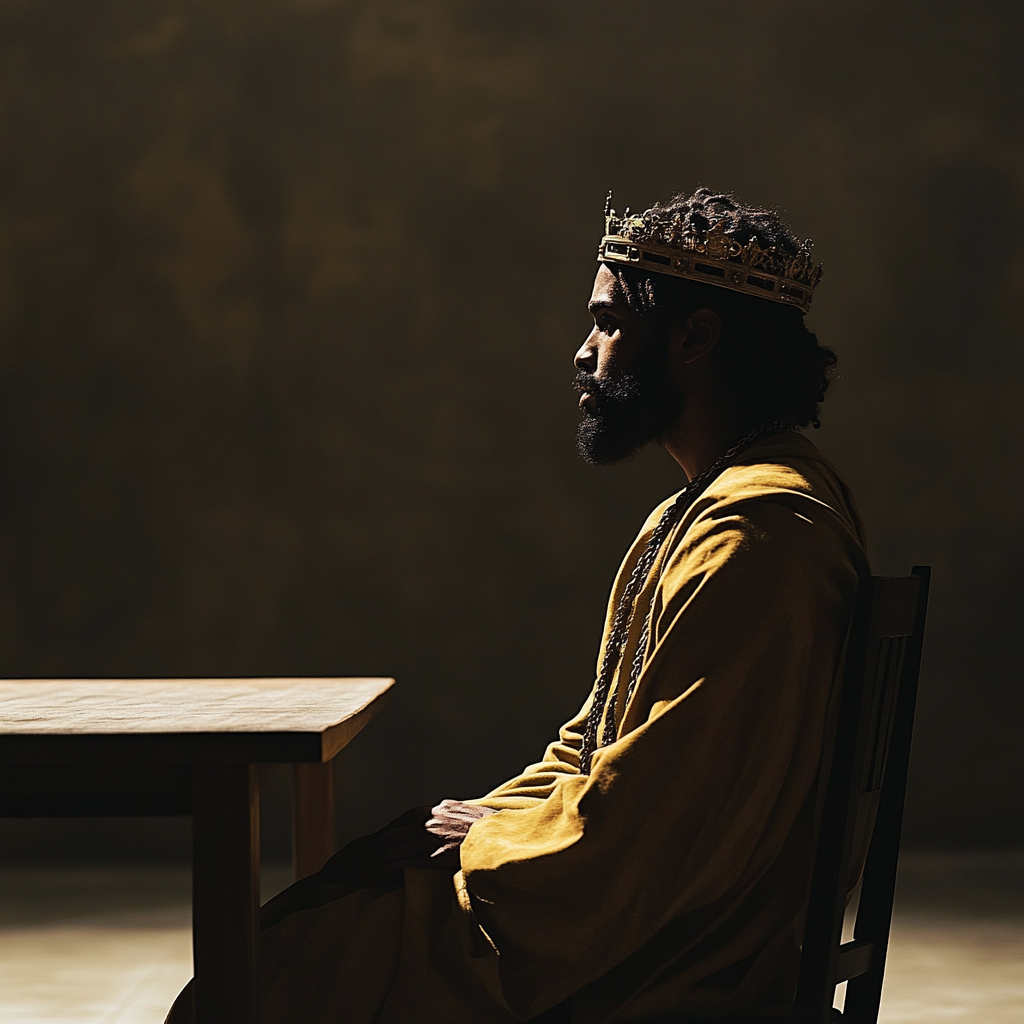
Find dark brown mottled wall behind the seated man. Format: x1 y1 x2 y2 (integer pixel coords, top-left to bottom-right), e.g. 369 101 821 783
0 0 1024 854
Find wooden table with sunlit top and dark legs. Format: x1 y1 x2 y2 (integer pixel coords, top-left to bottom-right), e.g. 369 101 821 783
0 679 394 1024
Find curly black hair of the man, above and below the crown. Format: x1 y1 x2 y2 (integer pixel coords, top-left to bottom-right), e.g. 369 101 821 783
605 188 837 429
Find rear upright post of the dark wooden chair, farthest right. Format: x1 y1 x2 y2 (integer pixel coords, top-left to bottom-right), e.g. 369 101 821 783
843 565 931 1024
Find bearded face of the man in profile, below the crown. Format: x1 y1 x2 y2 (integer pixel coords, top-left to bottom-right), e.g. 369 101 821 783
573 263 682 466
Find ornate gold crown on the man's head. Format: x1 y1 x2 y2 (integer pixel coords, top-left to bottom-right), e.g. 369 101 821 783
597 191 822 313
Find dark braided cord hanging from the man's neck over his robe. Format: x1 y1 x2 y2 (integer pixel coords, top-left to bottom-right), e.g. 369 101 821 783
580 420 795 775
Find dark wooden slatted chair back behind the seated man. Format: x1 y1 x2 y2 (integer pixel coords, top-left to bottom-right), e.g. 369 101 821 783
793 565 931 1024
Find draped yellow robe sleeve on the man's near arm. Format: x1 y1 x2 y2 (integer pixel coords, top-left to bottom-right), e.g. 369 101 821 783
462 491 859 1018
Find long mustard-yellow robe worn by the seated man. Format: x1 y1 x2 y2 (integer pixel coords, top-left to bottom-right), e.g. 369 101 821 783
262 433 868 1024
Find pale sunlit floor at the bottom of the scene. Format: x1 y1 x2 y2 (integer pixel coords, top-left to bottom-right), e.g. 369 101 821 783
0 854 1024 1024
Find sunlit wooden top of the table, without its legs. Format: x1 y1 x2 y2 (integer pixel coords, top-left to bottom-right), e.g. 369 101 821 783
0 678 394 762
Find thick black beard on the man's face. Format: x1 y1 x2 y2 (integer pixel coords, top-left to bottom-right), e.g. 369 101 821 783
572 337 683 466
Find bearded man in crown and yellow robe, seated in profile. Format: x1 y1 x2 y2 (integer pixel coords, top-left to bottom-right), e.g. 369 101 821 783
169 188 868 1024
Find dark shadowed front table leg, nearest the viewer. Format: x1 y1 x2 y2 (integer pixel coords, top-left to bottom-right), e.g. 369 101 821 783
193 763 259 1024
